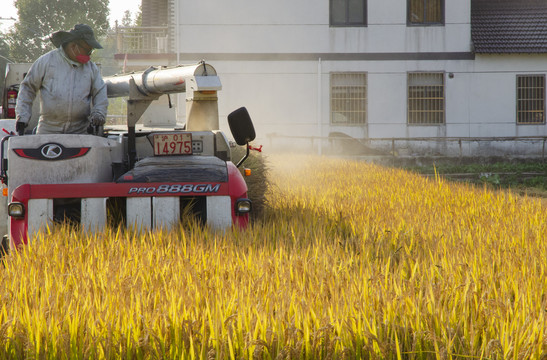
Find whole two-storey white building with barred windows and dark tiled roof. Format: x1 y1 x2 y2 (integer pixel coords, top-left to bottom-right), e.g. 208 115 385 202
117 0 547 156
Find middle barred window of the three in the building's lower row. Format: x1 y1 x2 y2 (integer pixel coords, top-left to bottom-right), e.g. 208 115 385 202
407 73 444 125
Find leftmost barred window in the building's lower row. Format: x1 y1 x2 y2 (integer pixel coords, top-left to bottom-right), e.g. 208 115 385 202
330 73 367 125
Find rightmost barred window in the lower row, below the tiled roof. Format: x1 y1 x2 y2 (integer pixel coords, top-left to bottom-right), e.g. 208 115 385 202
517 75 545 124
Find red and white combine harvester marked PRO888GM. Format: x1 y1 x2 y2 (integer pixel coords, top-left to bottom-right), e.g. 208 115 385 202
1 62 255 253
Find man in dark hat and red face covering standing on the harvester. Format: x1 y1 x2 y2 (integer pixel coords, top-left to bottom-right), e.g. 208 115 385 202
15 24 108 135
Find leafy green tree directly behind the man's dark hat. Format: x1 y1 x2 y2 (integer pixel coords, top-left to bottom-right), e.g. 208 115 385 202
7 0 109 62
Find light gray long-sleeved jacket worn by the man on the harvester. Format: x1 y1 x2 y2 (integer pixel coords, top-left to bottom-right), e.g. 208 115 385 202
15 48 108 134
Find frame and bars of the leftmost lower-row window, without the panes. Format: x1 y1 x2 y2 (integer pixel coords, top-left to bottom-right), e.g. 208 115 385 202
329 71 369 126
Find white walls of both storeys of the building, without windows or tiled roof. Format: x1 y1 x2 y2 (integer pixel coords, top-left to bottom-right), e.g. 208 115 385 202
179 0 547 152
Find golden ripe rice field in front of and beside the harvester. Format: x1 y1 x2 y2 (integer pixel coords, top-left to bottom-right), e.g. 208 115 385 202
0 156 547 359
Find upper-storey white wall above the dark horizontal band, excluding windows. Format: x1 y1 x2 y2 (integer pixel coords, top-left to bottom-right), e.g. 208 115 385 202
179 0 471 54
